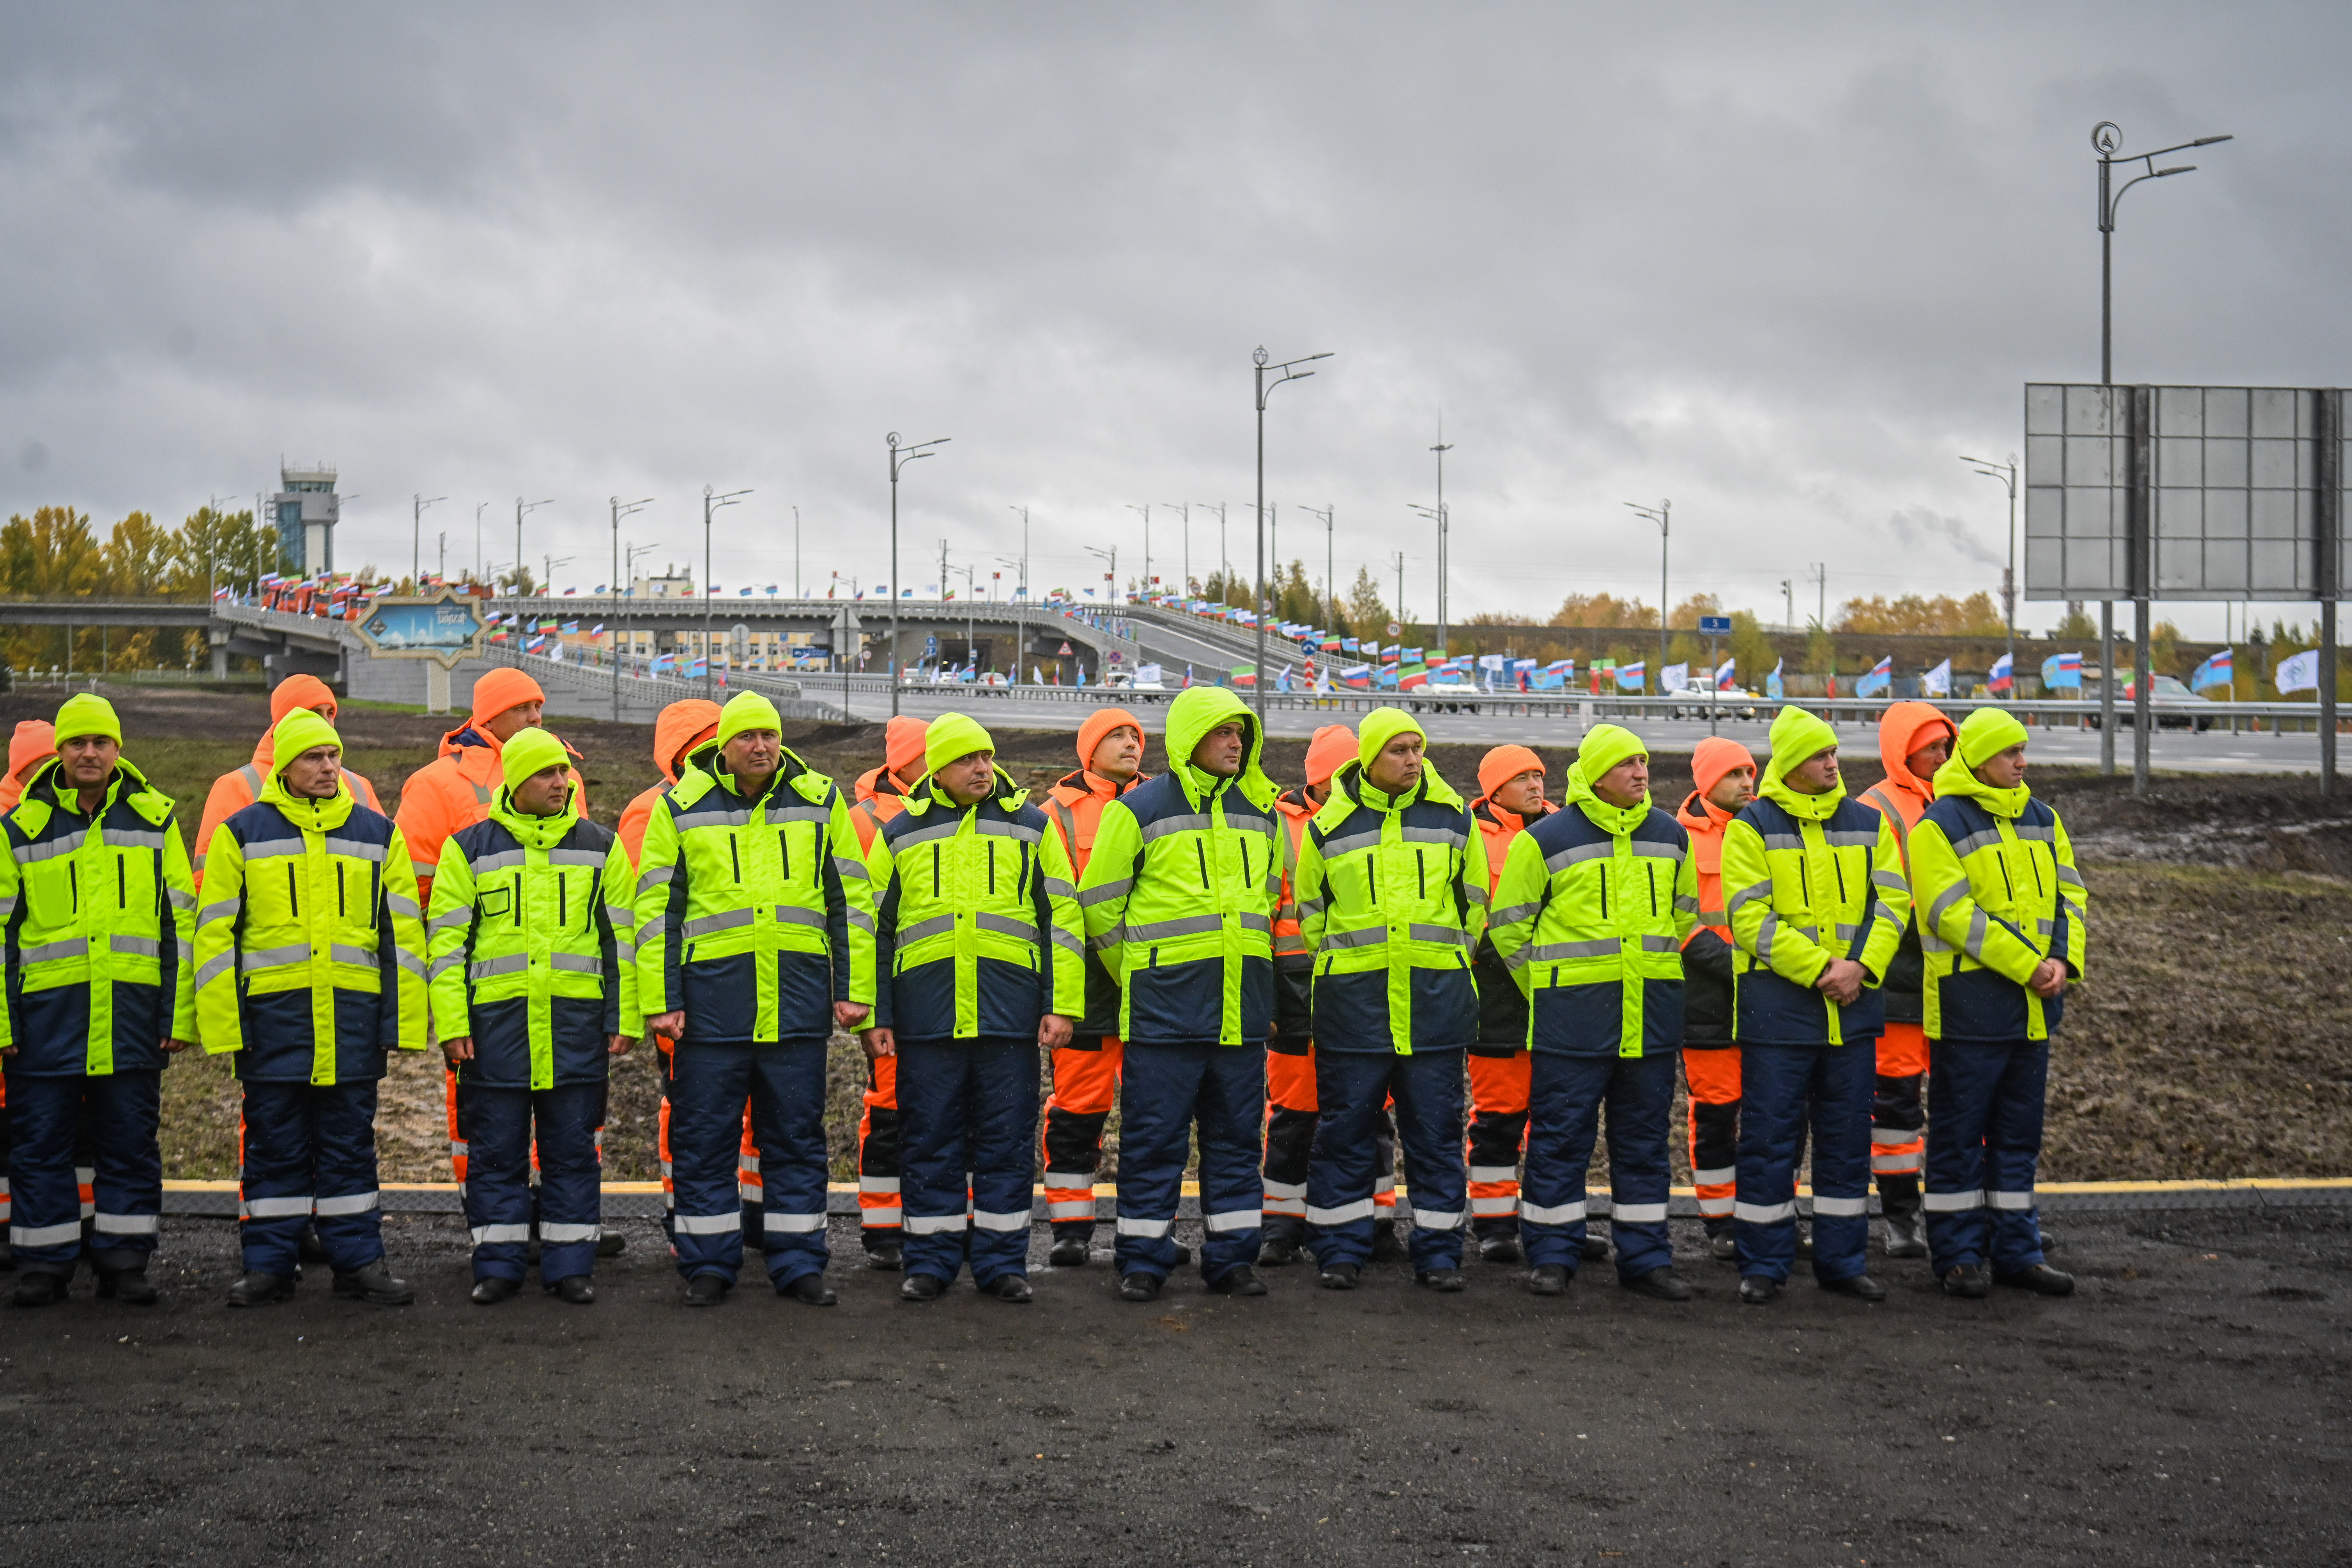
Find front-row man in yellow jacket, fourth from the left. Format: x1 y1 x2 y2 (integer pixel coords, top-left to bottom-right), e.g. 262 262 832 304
637 691 875 1307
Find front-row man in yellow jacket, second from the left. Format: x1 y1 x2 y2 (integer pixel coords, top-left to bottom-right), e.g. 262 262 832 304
195 708 426 1307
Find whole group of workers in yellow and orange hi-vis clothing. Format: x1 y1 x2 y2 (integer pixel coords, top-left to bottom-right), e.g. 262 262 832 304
0 670 2084 1307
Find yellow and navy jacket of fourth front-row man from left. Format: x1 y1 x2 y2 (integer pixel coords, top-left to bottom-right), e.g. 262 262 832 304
637 745 875 1044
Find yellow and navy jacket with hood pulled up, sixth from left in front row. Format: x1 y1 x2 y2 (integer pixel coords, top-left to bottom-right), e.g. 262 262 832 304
1077 687 1282 1046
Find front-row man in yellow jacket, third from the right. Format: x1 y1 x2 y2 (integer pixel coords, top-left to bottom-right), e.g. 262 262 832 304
1491 724 1698 1303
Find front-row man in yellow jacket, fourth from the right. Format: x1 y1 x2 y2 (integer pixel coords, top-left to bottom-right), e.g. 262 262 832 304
1298 708 1487 1290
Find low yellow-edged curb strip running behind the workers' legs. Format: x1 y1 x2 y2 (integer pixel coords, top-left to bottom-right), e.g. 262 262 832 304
162 1178 2352 1220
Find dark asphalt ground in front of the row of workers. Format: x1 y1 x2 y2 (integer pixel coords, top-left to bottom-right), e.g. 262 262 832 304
0 1208 2352 1566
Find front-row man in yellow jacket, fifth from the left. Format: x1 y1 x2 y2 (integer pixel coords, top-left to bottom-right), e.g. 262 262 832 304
865 712 1087 1303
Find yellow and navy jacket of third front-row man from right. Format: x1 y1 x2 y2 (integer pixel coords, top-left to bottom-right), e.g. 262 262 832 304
1491 773 1698 1055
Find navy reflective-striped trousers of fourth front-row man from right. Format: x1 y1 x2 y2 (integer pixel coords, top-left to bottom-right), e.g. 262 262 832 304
1308 1046 1470 1272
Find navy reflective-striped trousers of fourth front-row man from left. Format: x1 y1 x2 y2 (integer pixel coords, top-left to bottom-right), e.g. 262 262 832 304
670 1039 833 1288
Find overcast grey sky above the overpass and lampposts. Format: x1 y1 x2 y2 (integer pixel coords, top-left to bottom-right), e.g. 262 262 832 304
0 5 2352 632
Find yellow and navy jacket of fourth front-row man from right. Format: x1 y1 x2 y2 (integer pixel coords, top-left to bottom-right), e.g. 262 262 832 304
1298 762 1487 1055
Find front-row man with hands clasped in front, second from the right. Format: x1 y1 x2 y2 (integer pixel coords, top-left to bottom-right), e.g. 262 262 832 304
1724 708 1910 1305
